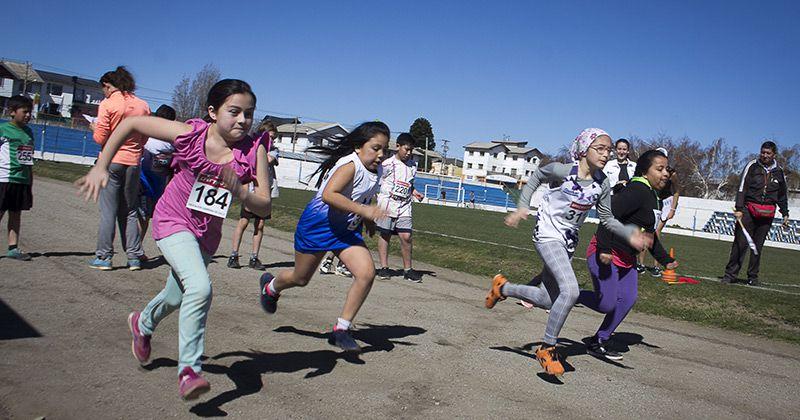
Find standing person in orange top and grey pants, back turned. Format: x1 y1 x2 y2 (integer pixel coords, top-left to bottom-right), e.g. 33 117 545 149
90 66 150 270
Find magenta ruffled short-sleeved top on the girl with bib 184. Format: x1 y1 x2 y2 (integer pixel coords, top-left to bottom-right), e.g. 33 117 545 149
153 119 269 254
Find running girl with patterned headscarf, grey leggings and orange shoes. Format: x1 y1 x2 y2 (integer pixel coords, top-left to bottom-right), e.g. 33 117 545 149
486 128 644 376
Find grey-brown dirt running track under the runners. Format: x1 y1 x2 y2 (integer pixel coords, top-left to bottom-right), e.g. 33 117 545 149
0 179 800 419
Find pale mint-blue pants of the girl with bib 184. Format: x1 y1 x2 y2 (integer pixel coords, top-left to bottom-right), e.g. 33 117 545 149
139 232 211 373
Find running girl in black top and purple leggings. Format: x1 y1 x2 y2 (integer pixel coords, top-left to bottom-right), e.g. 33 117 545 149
578 150 678 360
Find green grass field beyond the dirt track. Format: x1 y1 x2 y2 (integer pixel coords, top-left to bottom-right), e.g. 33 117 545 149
34 161 800 343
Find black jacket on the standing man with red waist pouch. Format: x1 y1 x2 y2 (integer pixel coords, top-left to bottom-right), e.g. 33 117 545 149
736 159 789 216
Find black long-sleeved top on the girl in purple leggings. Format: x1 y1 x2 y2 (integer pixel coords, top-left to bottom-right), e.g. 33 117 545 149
596 181 675 266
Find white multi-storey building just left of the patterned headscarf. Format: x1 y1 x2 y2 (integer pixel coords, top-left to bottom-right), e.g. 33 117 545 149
463 140 541 182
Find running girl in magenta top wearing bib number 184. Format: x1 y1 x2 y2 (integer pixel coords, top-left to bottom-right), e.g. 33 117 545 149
76 79 270 400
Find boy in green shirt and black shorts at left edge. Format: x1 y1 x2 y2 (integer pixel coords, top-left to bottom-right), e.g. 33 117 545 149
0 96 33 261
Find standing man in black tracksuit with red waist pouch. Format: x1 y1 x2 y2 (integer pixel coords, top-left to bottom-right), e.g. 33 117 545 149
722 141 789 286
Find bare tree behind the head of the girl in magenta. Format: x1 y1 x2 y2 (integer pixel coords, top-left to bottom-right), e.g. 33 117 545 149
172 63 222 121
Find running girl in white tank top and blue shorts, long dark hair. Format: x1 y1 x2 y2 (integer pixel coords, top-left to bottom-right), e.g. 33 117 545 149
260 122 389 352
